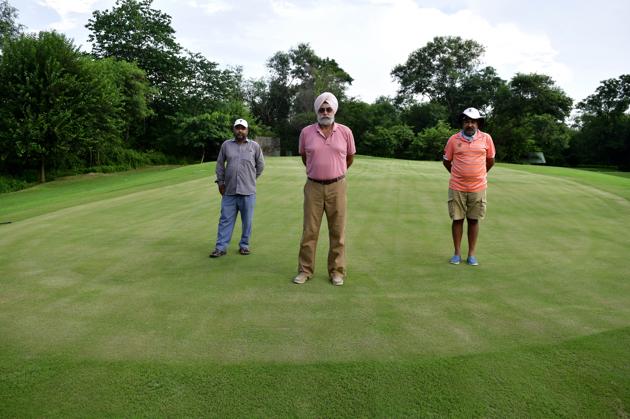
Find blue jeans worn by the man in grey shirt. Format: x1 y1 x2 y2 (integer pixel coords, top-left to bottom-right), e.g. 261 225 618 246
215 194 256 252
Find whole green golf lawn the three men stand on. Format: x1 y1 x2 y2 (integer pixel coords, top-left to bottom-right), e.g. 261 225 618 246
0 157 630 417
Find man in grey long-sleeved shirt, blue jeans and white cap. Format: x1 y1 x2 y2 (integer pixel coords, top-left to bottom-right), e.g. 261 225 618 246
210 119 265 258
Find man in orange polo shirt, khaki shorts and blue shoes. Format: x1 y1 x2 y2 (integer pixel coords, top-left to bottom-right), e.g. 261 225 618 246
443 108 495 266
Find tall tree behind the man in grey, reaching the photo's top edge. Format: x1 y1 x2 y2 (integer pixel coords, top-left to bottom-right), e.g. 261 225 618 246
86 0 243 157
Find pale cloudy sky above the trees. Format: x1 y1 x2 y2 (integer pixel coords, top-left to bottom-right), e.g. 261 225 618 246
8 0 630 103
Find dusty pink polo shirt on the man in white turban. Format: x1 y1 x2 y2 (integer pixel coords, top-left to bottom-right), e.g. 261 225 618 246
299 122 357 180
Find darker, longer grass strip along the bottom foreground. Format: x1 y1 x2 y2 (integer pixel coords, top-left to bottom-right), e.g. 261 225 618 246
0 328 630 418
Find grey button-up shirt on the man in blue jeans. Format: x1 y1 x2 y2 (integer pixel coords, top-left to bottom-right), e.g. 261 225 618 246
216 138 265 195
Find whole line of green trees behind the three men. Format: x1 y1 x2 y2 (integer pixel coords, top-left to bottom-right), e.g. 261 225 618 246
0 0 630 188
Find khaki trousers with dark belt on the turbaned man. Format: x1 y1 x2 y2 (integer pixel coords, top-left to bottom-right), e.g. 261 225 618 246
298 178 347 277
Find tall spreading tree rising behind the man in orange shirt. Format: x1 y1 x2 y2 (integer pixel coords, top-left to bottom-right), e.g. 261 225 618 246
391 36 502 123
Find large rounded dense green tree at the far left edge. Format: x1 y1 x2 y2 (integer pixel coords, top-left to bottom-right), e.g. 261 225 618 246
0 32 143 182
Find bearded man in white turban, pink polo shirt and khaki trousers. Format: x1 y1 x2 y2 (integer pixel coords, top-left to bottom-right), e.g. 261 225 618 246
293 92 356 285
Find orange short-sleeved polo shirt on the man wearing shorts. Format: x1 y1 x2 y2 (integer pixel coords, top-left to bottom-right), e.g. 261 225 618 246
444 130 496 192
